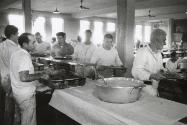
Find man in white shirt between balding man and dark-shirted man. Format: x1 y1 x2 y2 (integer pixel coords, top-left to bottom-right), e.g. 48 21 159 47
34 32 51 55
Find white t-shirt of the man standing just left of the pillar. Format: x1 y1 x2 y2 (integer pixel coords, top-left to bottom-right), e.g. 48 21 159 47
91 46 122 66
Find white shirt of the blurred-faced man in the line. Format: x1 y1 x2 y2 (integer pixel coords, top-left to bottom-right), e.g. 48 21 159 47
73 43 97 63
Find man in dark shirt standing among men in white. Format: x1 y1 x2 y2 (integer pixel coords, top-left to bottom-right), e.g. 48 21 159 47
51 32 74 57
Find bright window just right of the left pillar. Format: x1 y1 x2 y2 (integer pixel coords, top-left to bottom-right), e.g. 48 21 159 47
32 17 46 40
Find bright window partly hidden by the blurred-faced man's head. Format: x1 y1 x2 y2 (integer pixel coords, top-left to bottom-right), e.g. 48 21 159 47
79 20 90 41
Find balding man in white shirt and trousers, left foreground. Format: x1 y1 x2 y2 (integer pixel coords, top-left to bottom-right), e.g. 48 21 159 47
10 33 48 125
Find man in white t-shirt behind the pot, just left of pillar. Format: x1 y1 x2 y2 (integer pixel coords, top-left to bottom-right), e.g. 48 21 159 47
91 34 123 77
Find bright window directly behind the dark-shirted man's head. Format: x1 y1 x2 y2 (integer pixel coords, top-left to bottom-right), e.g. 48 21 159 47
51 18 64 37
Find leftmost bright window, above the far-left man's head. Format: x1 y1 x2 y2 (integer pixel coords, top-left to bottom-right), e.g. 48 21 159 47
8 14 25 35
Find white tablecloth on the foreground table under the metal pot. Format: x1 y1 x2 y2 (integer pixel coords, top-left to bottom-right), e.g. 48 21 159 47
49 81 187 125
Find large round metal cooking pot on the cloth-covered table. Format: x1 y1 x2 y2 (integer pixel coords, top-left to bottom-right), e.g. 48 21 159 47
95 77 144 103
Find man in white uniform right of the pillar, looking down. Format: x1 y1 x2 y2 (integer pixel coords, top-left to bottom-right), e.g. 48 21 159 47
132 29 166 96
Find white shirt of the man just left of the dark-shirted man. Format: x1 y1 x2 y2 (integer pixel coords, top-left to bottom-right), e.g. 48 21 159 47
35 42 51 54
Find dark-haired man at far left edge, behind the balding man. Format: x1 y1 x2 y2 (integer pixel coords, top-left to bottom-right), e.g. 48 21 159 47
0 25 18 125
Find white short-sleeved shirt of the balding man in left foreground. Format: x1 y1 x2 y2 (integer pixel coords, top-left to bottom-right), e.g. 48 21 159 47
10 48 36 99
